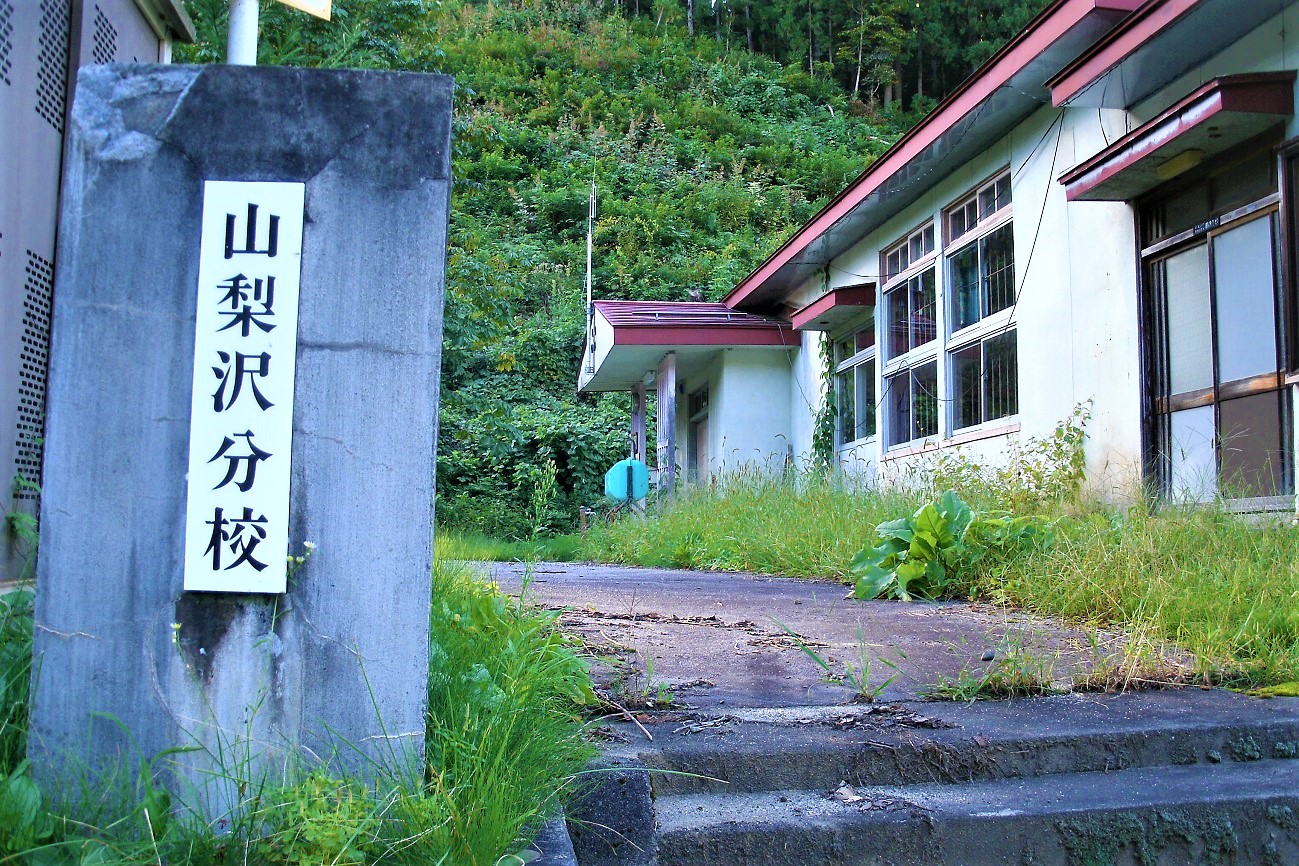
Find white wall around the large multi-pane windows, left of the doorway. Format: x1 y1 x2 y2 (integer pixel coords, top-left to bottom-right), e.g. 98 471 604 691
791 106 1141 496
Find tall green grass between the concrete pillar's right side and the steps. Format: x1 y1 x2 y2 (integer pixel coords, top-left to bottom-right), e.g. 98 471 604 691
429 565 595 863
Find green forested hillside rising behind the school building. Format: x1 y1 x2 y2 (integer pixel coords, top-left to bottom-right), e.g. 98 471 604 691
182 0 1044 536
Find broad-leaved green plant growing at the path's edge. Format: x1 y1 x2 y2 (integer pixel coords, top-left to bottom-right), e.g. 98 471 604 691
848 491 1052 601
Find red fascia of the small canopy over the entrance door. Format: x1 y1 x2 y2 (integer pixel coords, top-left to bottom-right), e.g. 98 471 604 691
1060 71 1295 201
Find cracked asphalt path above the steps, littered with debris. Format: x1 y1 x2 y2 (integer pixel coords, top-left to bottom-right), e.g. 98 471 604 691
491 562 1122 710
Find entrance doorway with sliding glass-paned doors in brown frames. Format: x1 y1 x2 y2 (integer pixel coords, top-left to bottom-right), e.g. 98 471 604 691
1142 153 1294 508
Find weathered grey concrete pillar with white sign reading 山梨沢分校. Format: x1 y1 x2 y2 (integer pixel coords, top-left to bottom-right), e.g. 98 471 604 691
31 66 452 814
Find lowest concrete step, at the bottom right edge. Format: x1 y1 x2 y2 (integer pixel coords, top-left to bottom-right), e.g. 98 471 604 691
654 760 1299 866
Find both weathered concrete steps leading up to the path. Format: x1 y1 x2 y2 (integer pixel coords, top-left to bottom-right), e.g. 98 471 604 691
569 689 1299 866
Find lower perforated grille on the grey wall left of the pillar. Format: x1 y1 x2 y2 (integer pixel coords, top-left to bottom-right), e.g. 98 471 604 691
14 249 55 499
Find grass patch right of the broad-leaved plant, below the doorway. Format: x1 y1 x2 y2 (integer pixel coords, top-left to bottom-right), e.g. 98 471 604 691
969 504 1299 686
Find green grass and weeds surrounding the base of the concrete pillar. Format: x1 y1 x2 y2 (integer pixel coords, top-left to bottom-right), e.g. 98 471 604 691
0 563 594 866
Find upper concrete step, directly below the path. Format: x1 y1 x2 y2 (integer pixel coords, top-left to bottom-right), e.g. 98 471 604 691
609 689 1299 796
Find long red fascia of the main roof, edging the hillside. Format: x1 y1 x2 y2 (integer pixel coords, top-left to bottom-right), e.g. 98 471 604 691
722 0 1142 308
